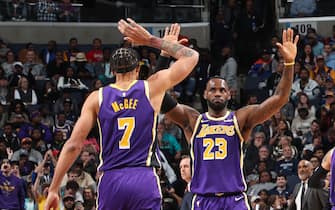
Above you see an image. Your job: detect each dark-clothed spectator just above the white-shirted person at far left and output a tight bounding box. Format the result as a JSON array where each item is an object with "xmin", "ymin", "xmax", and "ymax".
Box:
[{"xmin": 23, "ymin": 50, "xmax": 46, "ymax": 80}]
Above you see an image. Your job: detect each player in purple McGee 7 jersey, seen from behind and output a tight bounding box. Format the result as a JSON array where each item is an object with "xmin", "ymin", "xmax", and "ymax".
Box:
[{"xmin": 45, "ymin": 19, "xmax": 198, "ymax": 210}]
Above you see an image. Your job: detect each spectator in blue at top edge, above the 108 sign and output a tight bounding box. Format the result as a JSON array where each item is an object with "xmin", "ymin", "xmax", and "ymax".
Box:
[{"xmin": 290, "ymin": 0, "xmax": 316, "ymax": 17}]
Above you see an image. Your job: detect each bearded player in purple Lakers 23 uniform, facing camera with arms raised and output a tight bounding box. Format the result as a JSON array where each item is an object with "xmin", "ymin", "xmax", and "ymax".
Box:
[{"xmin": 163, "ymin": 29, "xmax": 299, "ymax": 210}]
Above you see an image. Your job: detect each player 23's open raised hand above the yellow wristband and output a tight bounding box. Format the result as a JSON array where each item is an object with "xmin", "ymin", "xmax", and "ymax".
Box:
[{"xmin": 276, "ymin": 28, "xmax": 299, "ymax": 63}]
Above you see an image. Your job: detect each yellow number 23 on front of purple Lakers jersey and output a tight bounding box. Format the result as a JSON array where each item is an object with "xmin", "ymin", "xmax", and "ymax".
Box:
[{"xmin": 202, "ymin": 138, "xmax": 227, "ymax": 160}]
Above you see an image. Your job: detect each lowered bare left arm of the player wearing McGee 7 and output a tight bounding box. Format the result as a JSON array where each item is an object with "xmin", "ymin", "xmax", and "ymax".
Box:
[{"xmin": 45, "ymin": 91, "xmax": 99, "ymax": 210}]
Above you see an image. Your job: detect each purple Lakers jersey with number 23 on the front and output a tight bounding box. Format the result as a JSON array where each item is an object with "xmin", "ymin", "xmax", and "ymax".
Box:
[{"xmin": 191, "ymin": 112, "xmax": 246, "ymax": 194}]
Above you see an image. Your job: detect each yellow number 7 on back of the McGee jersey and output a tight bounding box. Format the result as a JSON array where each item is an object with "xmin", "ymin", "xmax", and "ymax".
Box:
[{"xmin": 117, "ymin": 117, "xmax": 135, "ymax": 149}]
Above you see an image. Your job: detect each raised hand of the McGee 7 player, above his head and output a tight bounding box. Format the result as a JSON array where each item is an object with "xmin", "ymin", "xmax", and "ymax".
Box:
[{"xmin": 118, "ymin": 18, "xmax": 152, "ymax": 46}]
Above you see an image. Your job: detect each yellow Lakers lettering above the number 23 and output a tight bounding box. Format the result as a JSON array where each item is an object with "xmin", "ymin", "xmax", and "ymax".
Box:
[{"xmin": 196, "ymin": 124, "xmax": 235, "ymax": 138}]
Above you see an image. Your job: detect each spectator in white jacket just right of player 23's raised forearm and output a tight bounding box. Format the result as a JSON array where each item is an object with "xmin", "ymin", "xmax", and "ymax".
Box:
[{"xmin": 291, "ymin": 67, "xmax": 320, "ymax": 105}]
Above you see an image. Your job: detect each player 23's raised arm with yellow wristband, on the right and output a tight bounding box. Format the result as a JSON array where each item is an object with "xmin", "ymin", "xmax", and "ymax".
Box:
[{"xmin": 236, "ymin": 29, "xmax": 299, "ymax": 139}]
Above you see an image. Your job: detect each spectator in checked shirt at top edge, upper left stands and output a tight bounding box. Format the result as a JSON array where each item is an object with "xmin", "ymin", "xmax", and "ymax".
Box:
[{"xmin": 37, "ymin": 0, "xmax": 59, "ymax": 22}]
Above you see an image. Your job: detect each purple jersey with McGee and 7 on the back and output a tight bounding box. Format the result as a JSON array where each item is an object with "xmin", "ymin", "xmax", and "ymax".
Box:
[{"xmin": 98, "ymin": 80, "xmax": 157, "ymax": 171}]
